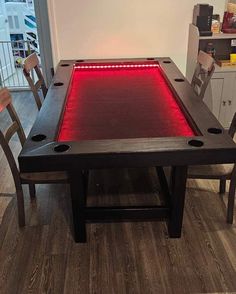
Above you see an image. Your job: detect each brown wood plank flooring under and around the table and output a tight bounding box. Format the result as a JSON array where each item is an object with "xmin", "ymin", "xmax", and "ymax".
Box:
[{"xmin": 0, "ymin": 92, "xmax": 236, "ymax": 294}]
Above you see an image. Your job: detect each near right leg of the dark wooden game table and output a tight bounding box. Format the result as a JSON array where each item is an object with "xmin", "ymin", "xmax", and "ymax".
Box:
[{"xmin": 168, "ymin": 166, "xmax": 187, "ymax": 238}]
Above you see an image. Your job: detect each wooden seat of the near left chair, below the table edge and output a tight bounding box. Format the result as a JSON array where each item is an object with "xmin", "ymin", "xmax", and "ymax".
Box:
[{"xmin": 20, "ymin": 171, "xmax": 69, "ymax": 184}]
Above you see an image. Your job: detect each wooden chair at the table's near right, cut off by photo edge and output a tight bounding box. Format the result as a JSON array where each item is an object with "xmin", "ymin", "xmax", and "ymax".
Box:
[{"xmin": 188, "ymin": 113, "xmax": 236, "ymax": 224}]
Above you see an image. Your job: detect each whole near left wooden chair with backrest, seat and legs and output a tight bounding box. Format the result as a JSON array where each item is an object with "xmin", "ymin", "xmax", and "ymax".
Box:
[{"xmin": 0, "ymin": 88, "xmax": 68, "ymax": 226}]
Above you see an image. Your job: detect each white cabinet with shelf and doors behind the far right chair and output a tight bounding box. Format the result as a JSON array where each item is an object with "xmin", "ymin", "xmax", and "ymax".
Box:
[{"xmin": 186, "ymin": 24, "xmax": 236, "ymax": 128}]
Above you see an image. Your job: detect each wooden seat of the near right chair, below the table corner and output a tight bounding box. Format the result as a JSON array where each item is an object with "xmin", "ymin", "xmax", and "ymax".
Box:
[{"xmin": 188, "ymin": 164, "xmax": 234, "ymax": 179}]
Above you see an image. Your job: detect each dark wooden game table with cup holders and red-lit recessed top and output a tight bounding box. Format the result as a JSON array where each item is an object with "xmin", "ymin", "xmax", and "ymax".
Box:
[{"xmin": 18, "ymin": 58, "xmax": 236, "ymax": 242}]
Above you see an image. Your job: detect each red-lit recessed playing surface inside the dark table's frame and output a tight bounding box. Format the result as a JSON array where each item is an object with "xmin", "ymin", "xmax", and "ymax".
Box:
[{"xmin": 58, "ymin": 63, "xmax": 195, "ymax": 141}]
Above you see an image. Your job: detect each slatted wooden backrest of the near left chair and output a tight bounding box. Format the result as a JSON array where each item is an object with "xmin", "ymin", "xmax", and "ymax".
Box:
[{"xmin": 0, "ymin": 88, "xmax": 26, "ymax": 189}]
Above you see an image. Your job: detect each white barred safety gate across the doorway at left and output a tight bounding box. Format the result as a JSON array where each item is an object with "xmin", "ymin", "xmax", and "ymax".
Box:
[{"xmin": 0, "ymin": 40, "xmax": 34, "ymax": 90}]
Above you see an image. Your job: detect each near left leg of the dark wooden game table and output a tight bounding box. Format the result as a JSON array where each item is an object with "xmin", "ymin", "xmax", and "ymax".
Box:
[{"xmin": 69, "ymin": 171, "xmax": 86, "ymax": 243}]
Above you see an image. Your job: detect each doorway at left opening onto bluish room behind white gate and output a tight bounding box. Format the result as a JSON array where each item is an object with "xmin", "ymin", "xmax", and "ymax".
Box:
[{"xmin": 0, "ymin": 0, "xmax": 53, "ymax": 90}]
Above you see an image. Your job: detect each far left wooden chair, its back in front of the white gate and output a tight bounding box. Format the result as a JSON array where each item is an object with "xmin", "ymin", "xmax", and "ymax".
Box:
[{"xmin": 23, "ymin": 53, "xmax": 47, "ymax": 109}]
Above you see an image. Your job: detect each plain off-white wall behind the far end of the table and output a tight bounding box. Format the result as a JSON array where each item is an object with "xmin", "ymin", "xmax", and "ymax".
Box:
[{"xmin": 48, "ymin": 0, "xmax": 225, "ymax": 73}]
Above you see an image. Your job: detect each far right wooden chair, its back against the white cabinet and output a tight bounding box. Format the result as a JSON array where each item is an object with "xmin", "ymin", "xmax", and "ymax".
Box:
[{"xmin": 191, "ymin": 50, "xmax": 215, "ymax": 99}]
